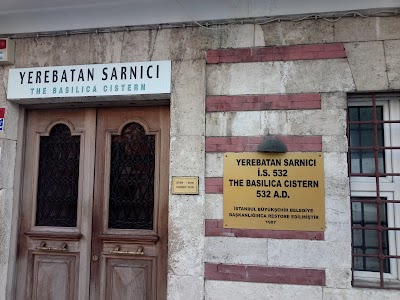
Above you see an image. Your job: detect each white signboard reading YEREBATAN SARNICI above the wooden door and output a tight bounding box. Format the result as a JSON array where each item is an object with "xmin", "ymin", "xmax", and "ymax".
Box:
[{"xmin": 7, "ymin": 61, "xmax": 171, "ymax": 100}]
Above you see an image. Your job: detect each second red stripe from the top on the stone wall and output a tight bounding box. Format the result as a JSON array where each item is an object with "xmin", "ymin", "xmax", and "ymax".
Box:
[{"xmin": 206, "ymin": 94, "xmax": 321, "ymax": 112}]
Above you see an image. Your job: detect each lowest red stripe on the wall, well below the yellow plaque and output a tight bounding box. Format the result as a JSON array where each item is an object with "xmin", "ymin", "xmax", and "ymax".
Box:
[{"xmin": 204, "ymin": 263, "xmax": 326, "ymax": 286}]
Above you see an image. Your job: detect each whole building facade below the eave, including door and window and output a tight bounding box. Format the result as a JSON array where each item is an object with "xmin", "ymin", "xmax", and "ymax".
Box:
[{"xmin": 0, "ymin": 8, "xmax": 400, "ymax": 300}]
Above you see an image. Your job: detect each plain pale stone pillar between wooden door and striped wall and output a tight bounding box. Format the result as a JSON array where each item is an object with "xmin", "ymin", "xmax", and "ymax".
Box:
[{"xmin": 168, "ymin": 60, "xmax": 205, "ymax": 300}]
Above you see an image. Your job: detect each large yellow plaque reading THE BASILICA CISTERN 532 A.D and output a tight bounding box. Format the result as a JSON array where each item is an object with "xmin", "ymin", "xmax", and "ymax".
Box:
[{"xmin": 224, "ymin": 152, "xmax": 325, "ymax": 231}]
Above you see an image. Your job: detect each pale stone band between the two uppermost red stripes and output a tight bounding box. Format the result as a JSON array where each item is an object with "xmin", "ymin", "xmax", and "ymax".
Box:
[{"xmin": 207, "ymin": 59, "xmax": 354, "ymax": 95}]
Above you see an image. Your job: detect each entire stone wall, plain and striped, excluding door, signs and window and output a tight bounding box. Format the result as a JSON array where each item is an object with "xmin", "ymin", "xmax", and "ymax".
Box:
[{"xmin": 0, "ymin": 17, "xmax": 400, "ymax": 300}]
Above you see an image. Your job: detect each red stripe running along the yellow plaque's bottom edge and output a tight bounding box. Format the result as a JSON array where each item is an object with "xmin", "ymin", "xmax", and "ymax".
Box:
[{"xmin": 205, "ymin": 219, "xmax": 325, "ymax": 241}]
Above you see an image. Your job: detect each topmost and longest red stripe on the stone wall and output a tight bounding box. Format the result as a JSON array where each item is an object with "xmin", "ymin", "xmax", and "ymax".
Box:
[{"xmin": 206, "ymin": 43, "xmax": 346, "ymax": 64}]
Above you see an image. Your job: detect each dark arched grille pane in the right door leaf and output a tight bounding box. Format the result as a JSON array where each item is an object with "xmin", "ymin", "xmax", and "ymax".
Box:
[{"xmin": 108, "ymin": 123, "xmax": 155, "ymax": 230}]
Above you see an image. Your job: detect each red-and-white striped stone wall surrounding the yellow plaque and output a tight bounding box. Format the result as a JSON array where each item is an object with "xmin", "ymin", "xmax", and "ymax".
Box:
[{"xmin": 205, "ymin": 18, "xmax": 400, "ymax": 300}]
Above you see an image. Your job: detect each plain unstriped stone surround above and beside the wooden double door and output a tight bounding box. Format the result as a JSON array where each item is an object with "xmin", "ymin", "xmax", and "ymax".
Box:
[{"xmin": 0, "ymin": 28, "xmax": 211, "ymax": 300}]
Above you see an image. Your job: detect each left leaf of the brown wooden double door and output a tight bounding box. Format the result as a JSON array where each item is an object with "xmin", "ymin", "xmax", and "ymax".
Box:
[{"xmin": 16, "ymin": 109, "xmax": 96, "ymax": 299}]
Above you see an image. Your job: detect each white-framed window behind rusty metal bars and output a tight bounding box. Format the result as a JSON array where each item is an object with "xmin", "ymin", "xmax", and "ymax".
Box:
[{"xmin": 347, "ymin": 93, "xmax": 400, "ymax": 289}]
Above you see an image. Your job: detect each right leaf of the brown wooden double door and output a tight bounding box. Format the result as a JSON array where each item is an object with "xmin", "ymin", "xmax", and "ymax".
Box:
[{"xmin": 91, "ymin": 107, "xmax": 169, "ymax": 300}]
